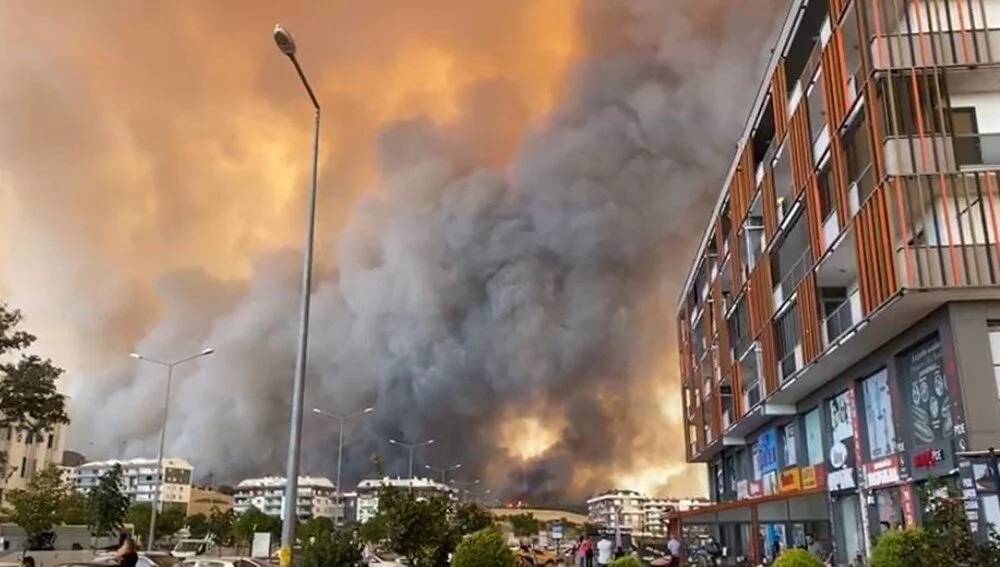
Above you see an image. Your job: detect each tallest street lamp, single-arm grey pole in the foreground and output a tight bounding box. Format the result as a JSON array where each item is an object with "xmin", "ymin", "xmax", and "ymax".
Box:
[{"xmin": 274, "ymin": 25, "xmax": 320, "ymax": 567}]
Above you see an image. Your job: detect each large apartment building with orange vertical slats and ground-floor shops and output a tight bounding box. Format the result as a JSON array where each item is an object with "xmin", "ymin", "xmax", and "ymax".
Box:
[{"xmin": 678, "ymin": 0, "xmax": 1000, "ymax": 562}]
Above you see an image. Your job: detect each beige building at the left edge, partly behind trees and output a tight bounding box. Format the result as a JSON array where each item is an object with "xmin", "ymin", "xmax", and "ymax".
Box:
[{"xmin": 0, "ymin": 425, "xmax": 66, "ymax": 502}]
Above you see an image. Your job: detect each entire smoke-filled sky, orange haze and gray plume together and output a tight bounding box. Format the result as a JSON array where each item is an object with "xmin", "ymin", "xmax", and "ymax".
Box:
[{"xmin": 0, "ymin": 0, "xmax": 783, "ymax": 499}]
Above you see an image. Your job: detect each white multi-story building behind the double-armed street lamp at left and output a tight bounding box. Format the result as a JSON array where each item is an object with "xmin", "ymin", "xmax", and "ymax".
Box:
[{"xmin": 68, "ymin": 458, "xmax": 194, "ymax": 510}]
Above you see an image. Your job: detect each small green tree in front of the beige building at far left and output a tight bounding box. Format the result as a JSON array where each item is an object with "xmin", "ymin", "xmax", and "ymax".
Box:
[{"xmin": 9, "ymin": 467, "xmax": 69, "ymax": 548}]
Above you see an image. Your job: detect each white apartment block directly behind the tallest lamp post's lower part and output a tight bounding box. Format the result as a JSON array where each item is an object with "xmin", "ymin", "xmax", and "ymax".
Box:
[{"xmin": 233, "ymin": 476, "xmax": 335, "ymax": 520}]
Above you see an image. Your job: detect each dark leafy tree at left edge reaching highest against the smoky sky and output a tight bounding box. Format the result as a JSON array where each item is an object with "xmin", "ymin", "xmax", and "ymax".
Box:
[{"xmin": 0, "ymin": 302, "xmax": 69, "ymax": 470}]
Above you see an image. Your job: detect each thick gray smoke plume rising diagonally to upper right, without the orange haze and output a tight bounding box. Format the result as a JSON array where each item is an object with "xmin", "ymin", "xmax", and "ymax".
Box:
[{"xmin": 7, "ymin": 0, "xmax": 785, "ymax": 500}]
